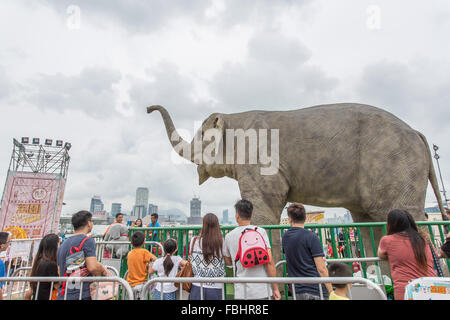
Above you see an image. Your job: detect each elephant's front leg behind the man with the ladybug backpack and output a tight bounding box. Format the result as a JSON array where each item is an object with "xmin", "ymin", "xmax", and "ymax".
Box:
[{"xmin": 238, "ymin": 170, "xmax": 289, "ymax": 275}]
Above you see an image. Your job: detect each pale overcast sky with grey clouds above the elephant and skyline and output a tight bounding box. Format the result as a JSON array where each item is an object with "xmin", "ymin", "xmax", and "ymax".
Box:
[{"xmin": 0, "ymin": 0, "xmax": 450, "ymax": 217}]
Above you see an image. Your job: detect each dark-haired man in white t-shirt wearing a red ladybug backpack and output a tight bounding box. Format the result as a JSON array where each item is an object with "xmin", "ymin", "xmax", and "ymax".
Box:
[{"xmin": 224, "ymin": 199, "xmax": 281, "ymax": 300}]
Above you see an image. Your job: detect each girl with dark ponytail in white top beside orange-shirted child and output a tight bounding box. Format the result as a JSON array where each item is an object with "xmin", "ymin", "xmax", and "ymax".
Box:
[{"xmin": 150, "ymin": 239, "xmax": 186, "ymax": 300}]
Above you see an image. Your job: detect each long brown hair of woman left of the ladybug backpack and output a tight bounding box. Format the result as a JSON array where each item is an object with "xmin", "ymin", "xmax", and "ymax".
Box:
[{"xmin": 200, "ymin": 213, "xmax": 223, "ymax": 263}]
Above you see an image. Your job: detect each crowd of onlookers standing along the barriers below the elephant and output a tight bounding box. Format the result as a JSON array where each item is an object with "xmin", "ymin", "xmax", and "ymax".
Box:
[{"xmin": 0, "ymin": 204, "xmax": 450, "ymax": 300}]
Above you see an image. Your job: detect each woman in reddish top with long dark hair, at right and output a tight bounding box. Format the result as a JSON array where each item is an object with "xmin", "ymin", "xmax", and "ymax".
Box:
[{"xmin": 378, "ymin": 209, "xmax": 436, "ymax": 300}]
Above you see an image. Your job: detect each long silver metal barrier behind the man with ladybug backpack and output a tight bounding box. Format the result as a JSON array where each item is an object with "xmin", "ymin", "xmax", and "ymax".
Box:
[{"xmin": 141, "ymin": 277, "xmax": 387, "ymax": 300}]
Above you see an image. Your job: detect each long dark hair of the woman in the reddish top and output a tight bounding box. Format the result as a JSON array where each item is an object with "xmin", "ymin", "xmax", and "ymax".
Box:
[{"xmin": 387, "ymin": 209, "xmax": 428, "ymax": 271}]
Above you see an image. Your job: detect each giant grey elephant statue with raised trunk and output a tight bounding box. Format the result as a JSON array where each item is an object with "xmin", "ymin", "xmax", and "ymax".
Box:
[{"xmin": 147, "ymin": 103, "xmax": 444, "ymax": 268}]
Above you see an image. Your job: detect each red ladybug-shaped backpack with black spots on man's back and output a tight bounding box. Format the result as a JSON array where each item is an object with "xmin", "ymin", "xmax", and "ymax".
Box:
[{"xmin": 234, "ymin": 227, "xmax": 269, "ymax": 268}]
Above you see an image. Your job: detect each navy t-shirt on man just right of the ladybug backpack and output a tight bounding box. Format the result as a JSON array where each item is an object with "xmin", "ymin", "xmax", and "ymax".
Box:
[{"xmin": 282, "ymin": 227, "xmax": 328, "ymax": 299}]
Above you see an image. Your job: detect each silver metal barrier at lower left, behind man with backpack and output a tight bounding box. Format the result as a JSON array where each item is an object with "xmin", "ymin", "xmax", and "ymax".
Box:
[{"xmin": 1, "ymin": 277, "xmax": 134, "ymax": 300}]
